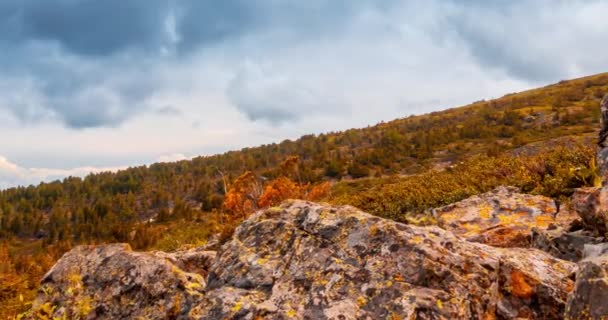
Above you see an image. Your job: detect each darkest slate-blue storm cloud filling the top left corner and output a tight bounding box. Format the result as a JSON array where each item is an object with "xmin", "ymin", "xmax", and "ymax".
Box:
[{"xmin": 0, "ymin": 0, "xmax": 168, "ymax": 56}]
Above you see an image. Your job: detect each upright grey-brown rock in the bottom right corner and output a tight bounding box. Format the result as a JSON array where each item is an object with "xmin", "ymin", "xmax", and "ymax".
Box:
[{"xmin": 565, "ymin": 255, "xmax": 608, "ymax": 320}]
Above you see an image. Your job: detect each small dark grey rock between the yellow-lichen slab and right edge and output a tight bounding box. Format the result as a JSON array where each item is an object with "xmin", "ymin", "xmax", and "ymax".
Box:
[{"xmin": 532, "ymin": 228, "xmax": 604, "ymax": 262}]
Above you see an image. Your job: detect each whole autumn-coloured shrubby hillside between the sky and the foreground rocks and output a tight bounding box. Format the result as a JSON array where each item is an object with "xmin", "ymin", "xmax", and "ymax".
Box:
[{"xmin": 0, "ymin": 74, "xmax": 608, "ymax": 318}]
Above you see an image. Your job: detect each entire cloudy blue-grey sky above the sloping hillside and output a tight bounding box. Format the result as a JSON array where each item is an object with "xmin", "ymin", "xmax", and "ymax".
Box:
[{"xmin": 0, "ymin": 0, "xmax": 608, "ymax": 188}]
